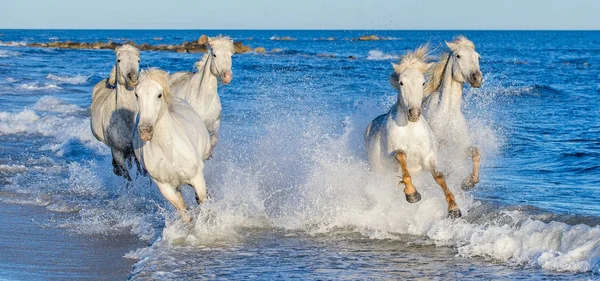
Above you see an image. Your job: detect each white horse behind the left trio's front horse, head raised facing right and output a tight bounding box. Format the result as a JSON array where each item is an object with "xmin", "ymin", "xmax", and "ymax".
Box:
[{"xmin": 169, "ymin": 36, "xmax": 235, "ymax": 158}]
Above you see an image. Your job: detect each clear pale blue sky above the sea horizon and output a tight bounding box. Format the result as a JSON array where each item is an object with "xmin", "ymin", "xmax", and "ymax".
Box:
[{"xmin": 0, "ymin": 0, "xmax": 600, "ymax": 30}]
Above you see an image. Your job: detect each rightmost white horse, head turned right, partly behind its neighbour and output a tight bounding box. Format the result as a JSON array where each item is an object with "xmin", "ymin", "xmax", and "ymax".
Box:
[{"xmin": 425, "ymin": 36, "xmax": 482, "ymax": 191}]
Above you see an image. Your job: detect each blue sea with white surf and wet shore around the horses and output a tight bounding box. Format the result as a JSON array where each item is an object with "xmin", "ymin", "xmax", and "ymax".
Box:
[{"xmin": 0, "ymin": 30, "xmax": 600, "ymax": 280}]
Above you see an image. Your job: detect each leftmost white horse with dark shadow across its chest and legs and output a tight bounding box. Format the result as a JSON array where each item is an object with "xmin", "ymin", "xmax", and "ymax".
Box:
[{"xmin": 90, "ymin": 45, "xmax": 140, "ymax": 180}]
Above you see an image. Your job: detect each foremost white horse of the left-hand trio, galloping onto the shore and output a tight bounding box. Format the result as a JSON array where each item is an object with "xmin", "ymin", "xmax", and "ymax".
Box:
[{"xmin": 133, "ymin": 69, "xmax": 210, "ymax": 222}]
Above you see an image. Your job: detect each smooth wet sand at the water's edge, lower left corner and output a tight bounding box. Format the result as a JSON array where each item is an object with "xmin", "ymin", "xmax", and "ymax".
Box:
[{"xmin": 0, "ymin": 203, "xmax": 146, "ymax": 280}]
